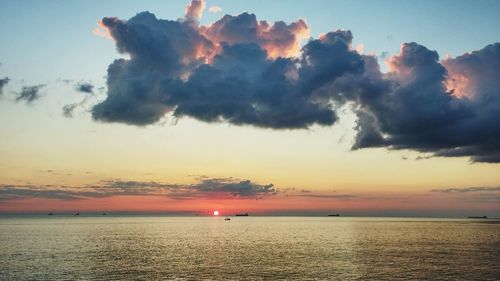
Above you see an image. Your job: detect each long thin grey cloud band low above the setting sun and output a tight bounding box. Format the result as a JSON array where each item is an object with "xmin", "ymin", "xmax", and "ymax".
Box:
[{"xmin": 0, "ymin": 178, "xmax": 278, "ymax": 200}]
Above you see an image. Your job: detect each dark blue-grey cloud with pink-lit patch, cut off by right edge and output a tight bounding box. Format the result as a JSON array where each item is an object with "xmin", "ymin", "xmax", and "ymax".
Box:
[{"xmin": 356, "ymin": 43, "xmax": 500, "ymax": 162}]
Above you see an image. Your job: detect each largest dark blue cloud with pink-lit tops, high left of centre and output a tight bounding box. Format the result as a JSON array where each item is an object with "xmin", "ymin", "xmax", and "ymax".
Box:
[{"xmin": 92, "ymin": 5, "xmax": 344, "ymax": 129}]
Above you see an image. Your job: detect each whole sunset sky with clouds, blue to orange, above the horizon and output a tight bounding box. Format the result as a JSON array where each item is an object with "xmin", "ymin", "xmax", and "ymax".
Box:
[{"xmin": 0, "ymin": 0, "xmax": 500, "ymax": 216}]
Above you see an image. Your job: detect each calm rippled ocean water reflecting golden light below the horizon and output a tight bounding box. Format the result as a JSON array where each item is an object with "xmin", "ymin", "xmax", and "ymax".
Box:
[{"xmin": 0, "ymin": 216, "xmax": 500, "ymax": 280}]
